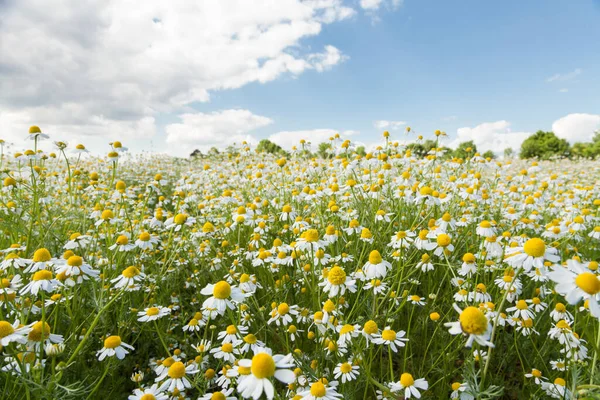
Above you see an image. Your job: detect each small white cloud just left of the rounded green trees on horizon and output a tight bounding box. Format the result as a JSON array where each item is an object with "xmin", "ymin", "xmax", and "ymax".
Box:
[{"xmin": 448, "ymin": 121, "xmax": 531, "ymax": 154}]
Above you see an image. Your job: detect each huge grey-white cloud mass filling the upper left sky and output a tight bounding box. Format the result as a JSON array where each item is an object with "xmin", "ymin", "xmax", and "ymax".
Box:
[{"xmin": 0, "ymin": 0, "xmax": 355, "ymax": 150}]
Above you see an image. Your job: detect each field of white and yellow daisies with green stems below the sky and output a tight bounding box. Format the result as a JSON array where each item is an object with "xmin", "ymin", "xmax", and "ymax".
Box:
[{"xmin": 0, "ymin": 127, "xmax": 600, "ymax": 400}]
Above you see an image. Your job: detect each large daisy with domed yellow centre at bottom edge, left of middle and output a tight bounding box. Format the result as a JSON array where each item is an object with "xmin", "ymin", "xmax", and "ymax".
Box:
[{"xmin": 237, "ymin": 348, "xmax": 296, "ymax": 400}]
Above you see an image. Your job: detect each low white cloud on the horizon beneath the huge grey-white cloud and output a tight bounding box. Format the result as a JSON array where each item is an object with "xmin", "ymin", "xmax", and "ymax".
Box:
[{"xmin": 165, "ymin": 110, "xmax": 273, "ymax": 155}]
